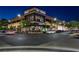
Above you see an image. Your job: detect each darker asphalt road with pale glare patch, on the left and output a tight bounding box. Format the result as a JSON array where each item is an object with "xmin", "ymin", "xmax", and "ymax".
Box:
[{"xmin": 0, "ymin": 34, "xmax": 52, "ymax": 46}]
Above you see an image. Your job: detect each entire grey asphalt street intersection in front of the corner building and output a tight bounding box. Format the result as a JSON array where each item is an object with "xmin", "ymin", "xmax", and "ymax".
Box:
[{"xmin": 0, "ymin": 33, "xmax": 79, "ymax": 49}]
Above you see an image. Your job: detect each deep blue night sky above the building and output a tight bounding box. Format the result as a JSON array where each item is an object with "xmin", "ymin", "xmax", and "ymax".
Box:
[{"xmin": 0, "ymin": 6, "xmax": 79, "ymax": 21}]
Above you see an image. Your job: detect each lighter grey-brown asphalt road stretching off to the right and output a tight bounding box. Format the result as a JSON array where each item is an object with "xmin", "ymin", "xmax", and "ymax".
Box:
[{"xmin": 41, "ymin": 33, "xmax": 79, "ymax": 49}]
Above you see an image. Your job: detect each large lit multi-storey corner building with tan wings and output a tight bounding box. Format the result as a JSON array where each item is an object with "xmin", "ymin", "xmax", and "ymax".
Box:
[{"xmin": 8, "ymin": 8, "xmax": 66, "ymax": 32}]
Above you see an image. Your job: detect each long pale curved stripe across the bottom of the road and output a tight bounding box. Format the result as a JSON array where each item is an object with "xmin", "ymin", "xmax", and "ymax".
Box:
[{"xmin": 0, "ymin": 46, "xmax": 79, "ymax": 51}]
